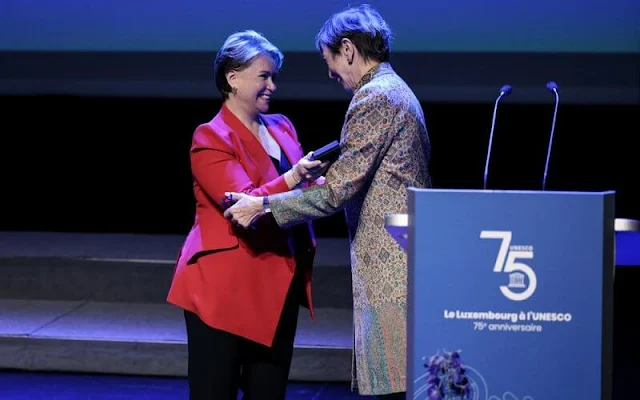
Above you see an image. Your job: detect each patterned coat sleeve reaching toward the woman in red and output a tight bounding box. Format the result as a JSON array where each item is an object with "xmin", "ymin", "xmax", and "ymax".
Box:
[{"xmin": 269, "ymin": 88, "xmax": 396, "ymax": 228}]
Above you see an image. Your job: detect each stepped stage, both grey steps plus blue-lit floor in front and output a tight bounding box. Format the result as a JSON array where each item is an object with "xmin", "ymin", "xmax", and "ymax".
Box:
[{"xmin": 0, "ymin": 232, "xmax": 640, "ymax": 400}]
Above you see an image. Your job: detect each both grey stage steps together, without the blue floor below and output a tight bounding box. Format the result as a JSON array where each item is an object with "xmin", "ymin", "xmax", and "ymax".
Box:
[{"xmin": 0, "ymin": 232, "xmax": 353, "ymax": 382}]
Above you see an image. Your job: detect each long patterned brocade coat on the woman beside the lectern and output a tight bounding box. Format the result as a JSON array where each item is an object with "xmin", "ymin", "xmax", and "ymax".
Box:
[{"xmin": 269, "ymin": 63, "xmax": 431, "ymax": 395}]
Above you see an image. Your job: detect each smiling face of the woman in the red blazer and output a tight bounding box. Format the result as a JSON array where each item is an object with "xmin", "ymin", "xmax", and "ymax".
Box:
[{"xmin": 227, "ymin": 55, "xmax": 278, "ymax": 113}]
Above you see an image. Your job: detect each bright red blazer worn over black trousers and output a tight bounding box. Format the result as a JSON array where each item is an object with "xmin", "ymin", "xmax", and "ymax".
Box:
[{"xmin": 167, "ymin": 105, "xmax": 316, "ymax": 346}]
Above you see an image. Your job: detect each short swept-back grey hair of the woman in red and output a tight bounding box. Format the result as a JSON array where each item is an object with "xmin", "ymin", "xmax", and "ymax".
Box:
[{"xmin": 213, "ymin": 30, "xmax": 284, "ymax": 99}]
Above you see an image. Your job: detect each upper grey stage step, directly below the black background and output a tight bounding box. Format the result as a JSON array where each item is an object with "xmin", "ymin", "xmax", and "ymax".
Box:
[{"xmin": 0, "ymin": 232, "xmax": 352, "ymax": 308}]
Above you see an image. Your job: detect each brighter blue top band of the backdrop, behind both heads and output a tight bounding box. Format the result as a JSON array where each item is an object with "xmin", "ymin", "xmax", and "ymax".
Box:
[{"xmin": 0, "ymin": 0, "xmax": 640, "ymax": 53}]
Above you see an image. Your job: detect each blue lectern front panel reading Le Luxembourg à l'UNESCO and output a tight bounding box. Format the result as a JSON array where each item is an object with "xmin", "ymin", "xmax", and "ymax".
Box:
[{"xmin": 408, "ymin": 190, "xmax": 614, "ymax": 400}]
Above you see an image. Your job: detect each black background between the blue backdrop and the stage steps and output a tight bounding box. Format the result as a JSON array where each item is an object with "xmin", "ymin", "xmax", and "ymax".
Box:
[{"xmin": 0, "ymin": 92, "xmax": 640, "ymax": 237}]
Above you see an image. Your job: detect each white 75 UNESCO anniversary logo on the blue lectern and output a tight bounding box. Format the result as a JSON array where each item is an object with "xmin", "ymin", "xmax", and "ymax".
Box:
[{"xmin": 480, "ymin": 231, "xmax": 538, "ymax": 301}]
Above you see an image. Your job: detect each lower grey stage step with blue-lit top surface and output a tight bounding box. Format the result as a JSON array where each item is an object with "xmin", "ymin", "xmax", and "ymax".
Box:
[{"xmin": 0, "ymin": 299, "xmax": 353, "ymax": 382}]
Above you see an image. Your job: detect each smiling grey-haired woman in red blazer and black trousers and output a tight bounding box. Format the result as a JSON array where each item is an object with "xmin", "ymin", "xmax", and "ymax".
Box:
[{"xmin": 167, "ymin": 31, "xmax": 322, "ymax": 400}]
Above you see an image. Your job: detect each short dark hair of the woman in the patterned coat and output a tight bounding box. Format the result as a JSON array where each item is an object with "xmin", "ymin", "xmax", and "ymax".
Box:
[{"xmin": 316, "ymin": 4, "xmax": 391, "ymax": 62}]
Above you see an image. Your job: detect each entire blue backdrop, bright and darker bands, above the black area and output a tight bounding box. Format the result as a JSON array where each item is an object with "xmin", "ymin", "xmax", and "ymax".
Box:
[{"xmin": 0, "ymin": 0, "xmax": 640, "ymax": 104}]
